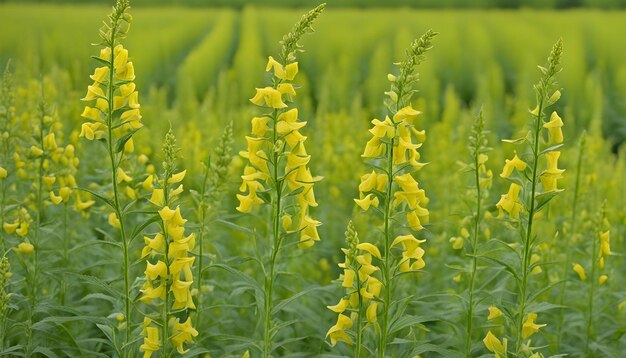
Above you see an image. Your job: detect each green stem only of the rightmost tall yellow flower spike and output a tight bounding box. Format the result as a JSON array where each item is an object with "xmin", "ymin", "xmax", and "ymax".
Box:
[{"xmin": 515, "ymin": 93, "xmax": 544, "ymax": 355}]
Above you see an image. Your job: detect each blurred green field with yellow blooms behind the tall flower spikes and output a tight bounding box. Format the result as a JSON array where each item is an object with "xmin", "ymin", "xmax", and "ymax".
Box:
[{"xmin": 0, "ymin": 2, "xmax": 626, "ymax": 358}]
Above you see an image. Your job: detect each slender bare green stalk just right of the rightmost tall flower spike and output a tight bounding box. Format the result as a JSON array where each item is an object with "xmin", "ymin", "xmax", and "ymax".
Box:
[{"xmin": 556, "ymin": 132, "xmax": 585, "ymax": 349}]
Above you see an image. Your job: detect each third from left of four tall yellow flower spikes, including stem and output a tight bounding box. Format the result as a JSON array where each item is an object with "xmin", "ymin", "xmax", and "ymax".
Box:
[{"xmin": 355, "ymin": 30, "xmax": 437, "ymax": 358}]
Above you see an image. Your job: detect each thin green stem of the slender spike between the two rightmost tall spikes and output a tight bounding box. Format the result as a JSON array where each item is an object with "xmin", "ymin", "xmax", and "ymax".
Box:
[{"xmin": 465, "ymin": 144, "xmax": 482, "ymax": 358}]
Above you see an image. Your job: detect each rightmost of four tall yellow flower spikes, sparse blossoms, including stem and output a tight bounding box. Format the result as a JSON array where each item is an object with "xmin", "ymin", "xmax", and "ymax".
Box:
[{"xmin": 488, "ymin": 40, "xmax": 564, "ymax": 356}]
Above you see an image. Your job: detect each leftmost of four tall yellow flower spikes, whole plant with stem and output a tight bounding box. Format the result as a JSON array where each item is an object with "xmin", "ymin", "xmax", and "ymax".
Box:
[{"xmin": 80, "ymin": 0, "xmax": 143, "ymax": 356}]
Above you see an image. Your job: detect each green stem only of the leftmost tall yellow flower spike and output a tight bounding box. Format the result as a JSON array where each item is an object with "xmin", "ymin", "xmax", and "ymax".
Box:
[{"xmin": 107, "ymin": 37, "xmax": 132, "ymax": 357}]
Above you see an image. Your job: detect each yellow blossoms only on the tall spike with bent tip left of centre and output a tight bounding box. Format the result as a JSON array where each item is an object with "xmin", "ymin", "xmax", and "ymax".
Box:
[{"xmin": 237, "ymin": 56, "xmax": 321, "ymax": 248}]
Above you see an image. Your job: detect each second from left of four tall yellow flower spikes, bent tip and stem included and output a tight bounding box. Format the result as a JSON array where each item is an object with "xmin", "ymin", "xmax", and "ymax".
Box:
[{"xmin": 237, "ymin": 4, "xmax": 325, "ymax": 357}]
